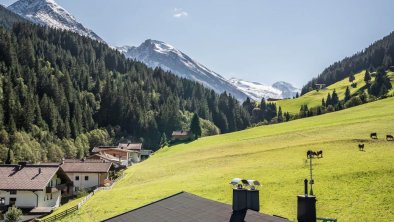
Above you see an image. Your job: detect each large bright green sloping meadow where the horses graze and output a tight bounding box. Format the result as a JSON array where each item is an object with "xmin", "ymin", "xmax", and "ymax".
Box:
[{"xmin": 63, "ymin": 97, "xmax": 394, "ymax": 221}]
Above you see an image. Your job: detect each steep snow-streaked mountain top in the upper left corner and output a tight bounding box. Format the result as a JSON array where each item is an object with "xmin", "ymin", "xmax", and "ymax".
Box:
[{"xmin": 8, "ymin": 0, "xmax": 104, "ymax": 42}]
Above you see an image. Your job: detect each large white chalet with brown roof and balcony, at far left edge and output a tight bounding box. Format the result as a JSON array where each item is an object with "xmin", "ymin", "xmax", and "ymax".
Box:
[{"xmin": 0, "ymin": 162, "xmax": 73, "ymax": 213}]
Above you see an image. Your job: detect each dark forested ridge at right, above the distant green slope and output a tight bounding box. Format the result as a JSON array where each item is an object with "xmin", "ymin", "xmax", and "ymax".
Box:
[{"xmin": 301, "ymin": 32, "xmax": 394, "ymax": 95}]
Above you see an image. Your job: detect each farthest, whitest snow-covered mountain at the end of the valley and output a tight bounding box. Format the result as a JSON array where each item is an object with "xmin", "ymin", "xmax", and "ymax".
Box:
[{"xmin": 230, "ymin": 78, "xmax": 299, "ymax": 101}]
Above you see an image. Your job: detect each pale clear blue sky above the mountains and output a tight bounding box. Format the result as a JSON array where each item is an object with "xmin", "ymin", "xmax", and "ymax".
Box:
[{"xmin": 0, "ymin": 0, "xmax": 394, "ymax": 87}]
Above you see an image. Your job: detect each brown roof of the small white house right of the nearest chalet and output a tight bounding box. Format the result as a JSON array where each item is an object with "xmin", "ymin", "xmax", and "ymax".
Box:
[{"xmin": 60, "ymin": 160, "xmax": 112, "ymax": 173}]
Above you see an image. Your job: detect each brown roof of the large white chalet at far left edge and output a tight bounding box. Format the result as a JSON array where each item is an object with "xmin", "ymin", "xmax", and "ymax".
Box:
[{"xmin": 0, "ymin": 165, "xmax": 59, "ymax": 190}]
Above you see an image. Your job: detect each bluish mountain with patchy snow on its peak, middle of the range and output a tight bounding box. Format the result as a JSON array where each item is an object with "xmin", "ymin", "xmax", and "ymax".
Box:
[{"xmin": 118, "ymin": 39, "xmax": 247, "ymax": 101}]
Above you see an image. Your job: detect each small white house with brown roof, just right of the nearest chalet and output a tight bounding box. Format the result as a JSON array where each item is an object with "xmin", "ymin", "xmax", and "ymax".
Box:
[{"xmin": 60, "ymin": 159, "xmax": 112, "ymax": 191}]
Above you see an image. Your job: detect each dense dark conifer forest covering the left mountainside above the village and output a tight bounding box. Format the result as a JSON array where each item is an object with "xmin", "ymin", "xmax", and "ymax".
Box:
[{"xmin": 0, "ymin": 12, "xmax": 250, "ymax": 162}]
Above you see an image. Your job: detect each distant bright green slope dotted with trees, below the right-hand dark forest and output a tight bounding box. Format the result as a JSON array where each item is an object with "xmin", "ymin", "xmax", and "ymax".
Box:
[{"xmin": 277, "ymin": 71, "xmax": 394, "ymax": 114}]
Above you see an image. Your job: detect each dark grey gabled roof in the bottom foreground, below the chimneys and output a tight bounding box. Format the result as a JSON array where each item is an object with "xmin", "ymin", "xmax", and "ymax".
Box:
[{"xmin": 104, "ymin": 192, "xmax": 288, "ymax": 222}]
